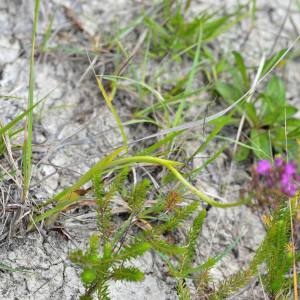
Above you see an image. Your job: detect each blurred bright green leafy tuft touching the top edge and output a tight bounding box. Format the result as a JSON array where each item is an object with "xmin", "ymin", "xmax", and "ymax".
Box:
[{"xmin": 145, "ymin": 0, "xmax": 244, "ymax": 58}]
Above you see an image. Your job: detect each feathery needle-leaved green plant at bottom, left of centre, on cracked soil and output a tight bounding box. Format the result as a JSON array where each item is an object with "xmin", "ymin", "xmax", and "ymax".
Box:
[{"xmin": 70, "ymin": 165, "xmax": 184, "ymax": 299}]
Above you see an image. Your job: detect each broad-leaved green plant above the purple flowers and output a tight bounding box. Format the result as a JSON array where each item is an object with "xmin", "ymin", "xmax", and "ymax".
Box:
[{"xmin": 215, "ymin": 50, "xmax": 300, "ymax": 160}]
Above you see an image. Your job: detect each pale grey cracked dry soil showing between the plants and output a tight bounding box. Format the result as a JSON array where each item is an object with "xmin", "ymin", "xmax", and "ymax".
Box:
[{"xmin": 0, "ymin": 0, "xmax": 300, "ymax": 300}]
